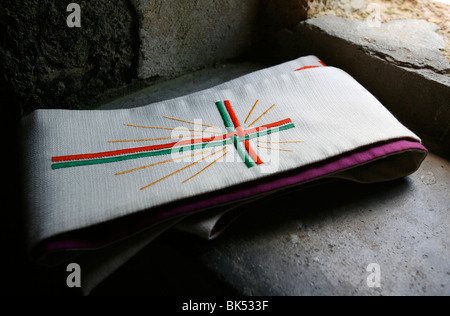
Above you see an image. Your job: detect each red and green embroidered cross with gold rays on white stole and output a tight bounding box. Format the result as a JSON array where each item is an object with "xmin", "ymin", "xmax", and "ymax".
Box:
[{"xmin": 52, "ymin": 61, "xmax": 326, "ymax": 190}]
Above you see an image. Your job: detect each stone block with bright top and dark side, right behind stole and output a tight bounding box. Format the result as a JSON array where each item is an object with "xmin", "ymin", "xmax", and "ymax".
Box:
[{"xmin": 270, "ymin": 17, "xmax": 450, "ymax": 158}]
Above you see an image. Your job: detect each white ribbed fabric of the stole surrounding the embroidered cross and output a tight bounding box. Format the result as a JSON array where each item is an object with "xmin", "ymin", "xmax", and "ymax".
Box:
[{"xmin": 23, "ymin": 56, "xmax": 423, "ymax": 289}]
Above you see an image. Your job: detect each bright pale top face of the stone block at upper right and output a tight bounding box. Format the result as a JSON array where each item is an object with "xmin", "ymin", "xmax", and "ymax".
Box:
[{"xmin": 308, "ymin": 16, "xmax": 450, "ymax": 74}]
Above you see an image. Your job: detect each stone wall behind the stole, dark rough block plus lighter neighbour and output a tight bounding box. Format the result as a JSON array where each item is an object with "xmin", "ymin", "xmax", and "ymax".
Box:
[{"xmin": 0, "ymin": 0, "xmax": 260, "ymax": 116}]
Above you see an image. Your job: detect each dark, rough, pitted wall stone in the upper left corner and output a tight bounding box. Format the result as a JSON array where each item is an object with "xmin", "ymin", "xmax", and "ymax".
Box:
[{"xmin": 0, "ymin": 0, "xmax": 137, "ymax": 115}]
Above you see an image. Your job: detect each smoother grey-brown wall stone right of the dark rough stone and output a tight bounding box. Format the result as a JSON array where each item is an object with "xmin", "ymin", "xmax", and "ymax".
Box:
[{"xmin": 134, "ymin": 0, "xmax": 259, "ymax": 79}]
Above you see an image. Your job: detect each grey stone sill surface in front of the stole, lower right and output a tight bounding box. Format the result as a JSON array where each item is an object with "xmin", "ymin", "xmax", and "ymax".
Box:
[{"xmin": 198, "ymin": 155, "xmax": 450, "ymax": 295}]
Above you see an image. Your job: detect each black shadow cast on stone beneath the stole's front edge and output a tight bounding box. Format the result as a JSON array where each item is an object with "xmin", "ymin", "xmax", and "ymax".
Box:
[{"xmin": 87, "ymin": 179, "xmax": 409, "ymax": 296}]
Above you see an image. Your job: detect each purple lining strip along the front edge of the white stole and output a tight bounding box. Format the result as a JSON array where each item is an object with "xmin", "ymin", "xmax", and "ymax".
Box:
[{"xmin": 33, "ymin": 140, "xmax": 427, "ymax": 255}]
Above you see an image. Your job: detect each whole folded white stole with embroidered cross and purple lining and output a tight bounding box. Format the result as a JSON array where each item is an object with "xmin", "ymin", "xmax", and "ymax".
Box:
[{"xmin": 22, "ymin": 56, "xmax": 427, "ymax": 292}]
